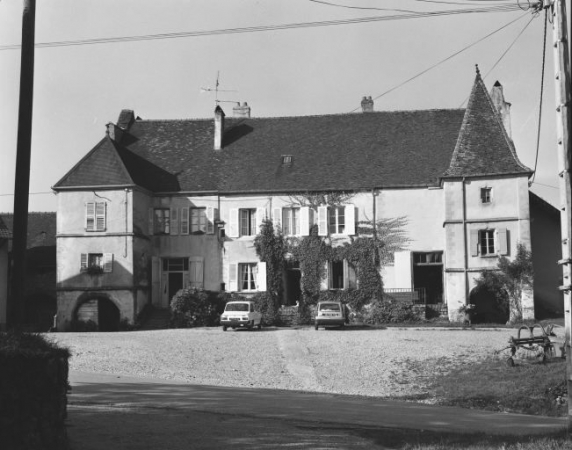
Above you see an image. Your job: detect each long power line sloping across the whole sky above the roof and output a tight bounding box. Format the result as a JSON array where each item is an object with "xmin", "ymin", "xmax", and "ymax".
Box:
[{"xmin": 0, "ymin": 5, "xmax": 520, "ymax": 51}]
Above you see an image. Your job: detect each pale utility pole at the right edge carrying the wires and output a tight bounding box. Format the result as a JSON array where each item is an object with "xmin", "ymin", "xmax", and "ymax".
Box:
[{"xmin": 545, "ymin": 0, "xmax": 572, "ymax": 432}]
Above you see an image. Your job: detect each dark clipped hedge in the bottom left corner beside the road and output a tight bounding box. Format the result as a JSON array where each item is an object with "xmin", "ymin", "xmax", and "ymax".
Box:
[{"xmin": 0, "ymin": 333, "xmax": 70, "ymax": 450}]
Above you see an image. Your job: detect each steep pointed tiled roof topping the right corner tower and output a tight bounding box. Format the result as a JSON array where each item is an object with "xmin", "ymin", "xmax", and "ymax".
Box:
[{"xmin": 445, "ymin": 72, "xmax": 532, "ymax": 177}]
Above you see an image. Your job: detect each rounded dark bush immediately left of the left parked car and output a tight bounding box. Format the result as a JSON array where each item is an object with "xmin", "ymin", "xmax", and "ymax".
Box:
[{"xmin": 170, "ymin": 288, "xmax": 228, "ymax": 328}]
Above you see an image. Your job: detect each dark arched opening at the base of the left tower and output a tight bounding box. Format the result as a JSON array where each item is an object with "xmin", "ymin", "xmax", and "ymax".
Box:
[{"xmin": 72, "ymin": 292, "xmax": 121, "ymax": 331}]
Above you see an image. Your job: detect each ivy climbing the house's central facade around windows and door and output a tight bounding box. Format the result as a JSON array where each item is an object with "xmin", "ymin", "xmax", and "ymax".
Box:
[{"xmin": 254, "ymin": 193, "xmax": 409, "ymax": 321}]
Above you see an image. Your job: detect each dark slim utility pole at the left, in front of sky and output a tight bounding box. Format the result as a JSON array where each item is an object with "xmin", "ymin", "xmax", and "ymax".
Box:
[{"xmin": 8, "ymin": 0, "xmax": 36, "ymax": 328}]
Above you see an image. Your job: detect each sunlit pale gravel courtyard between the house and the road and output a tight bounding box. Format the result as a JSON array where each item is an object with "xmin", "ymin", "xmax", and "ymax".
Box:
[{"xmin": 48, "ymin": 327, "xmax": 540, "ymax": 397}]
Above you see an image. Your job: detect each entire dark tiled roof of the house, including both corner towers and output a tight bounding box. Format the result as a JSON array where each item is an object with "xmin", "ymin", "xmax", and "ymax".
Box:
[{"xmin": 54, "ymin": 76, "xmax": 529, "ymax": 193}]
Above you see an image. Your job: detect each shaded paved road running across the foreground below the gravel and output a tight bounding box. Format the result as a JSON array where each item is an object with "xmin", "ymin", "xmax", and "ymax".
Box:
[{"xmin": 68, "ymin": 371, "xmax": 565, "ymax": 450}]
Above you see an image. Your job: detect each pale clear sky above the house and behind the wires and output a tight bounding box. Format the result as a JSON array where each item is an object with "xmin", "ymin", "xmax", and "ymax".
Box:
[{"xmin": 0, "ymin": 0, "xmax": 570, "ymax": 212}]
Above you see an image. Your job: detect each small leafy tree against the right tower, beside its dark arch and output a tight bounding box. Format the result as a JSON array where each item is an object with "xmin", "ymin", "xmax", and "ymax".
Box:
[{"xmin": 477, "ymin": 244, "xmax": 534, "ymax": 323}]
